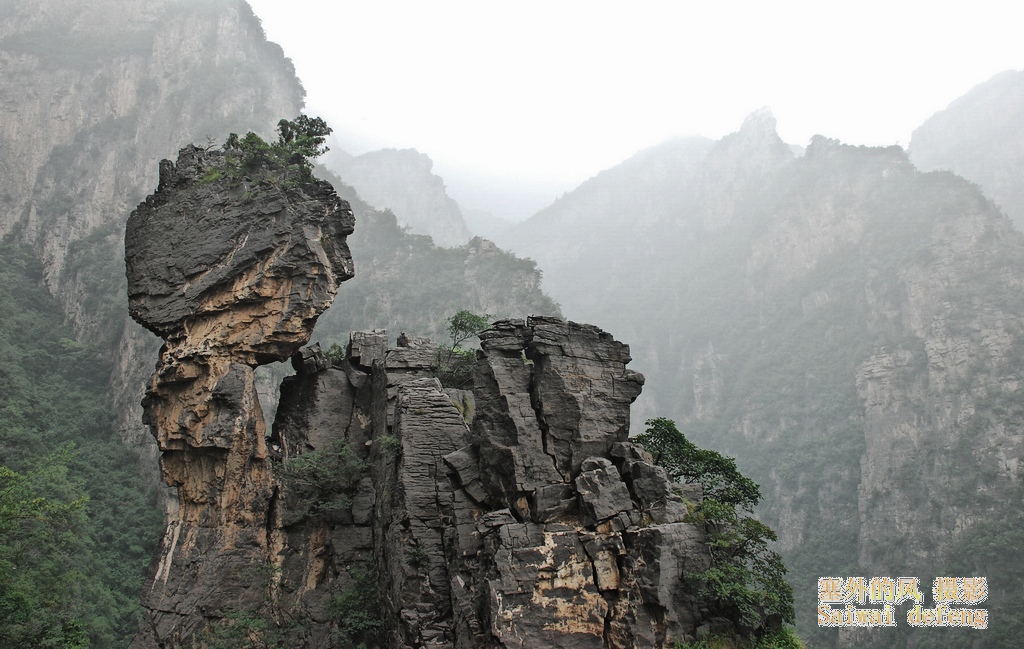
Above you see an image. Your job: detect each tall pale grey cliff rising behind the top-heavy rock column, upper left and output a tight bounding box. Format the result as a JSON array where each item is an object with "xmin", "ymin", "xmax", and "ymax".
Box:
[{"xmin": 0, "ymin": 0, "xmax": 304, "ymax": 481}]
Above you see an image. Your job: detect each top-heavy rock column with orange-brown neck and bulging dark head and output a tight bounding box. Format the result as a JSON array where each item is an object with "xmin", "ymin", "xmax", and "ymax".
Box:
[{"xmin": 125, "ymin": 146, "xmax": 354, "ymax": 647}]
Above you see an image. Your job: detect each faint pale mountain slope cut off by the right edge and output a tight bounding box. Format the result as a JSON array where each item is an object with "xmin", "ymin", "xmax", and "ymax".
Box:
[{"xmin": 909, "ymin": 70, "xmax": 1024, "ymax": 227}]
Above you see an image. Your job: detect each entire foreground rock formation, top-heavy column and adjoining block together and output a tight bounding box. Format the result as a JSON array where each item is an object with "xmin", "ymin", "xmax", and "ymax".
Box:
[{"xmin": 125, "ymin": 146, "xmax": 714, "ymax": 649}]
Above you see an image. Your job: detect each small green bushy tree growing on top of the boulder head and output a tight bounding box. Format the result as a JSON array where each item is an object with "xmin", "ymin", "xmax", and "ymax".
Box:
[{"xmin": 223, "ymin": 115, "xmax": 332, "ymax": 182}]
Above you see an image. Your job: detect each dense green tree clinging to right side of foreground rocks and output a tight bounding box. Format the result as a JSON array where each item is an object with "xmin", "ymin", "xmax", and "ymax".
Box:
[{"xmin": 636, "ymin": 418, "xmax": 796, "ymax": 638}]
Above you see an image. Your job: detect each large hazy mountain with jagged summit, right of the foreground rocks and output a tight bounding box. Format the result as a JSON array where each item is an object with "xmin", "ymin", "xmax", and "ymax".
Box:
[{"xmin": 501, "ymin": 112, "xmax": 1024, "ymax": 647}]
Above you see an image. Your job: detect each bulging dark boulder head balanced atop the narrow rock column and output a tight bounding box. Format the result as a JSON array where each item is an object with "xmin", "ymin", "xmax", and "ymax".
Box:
[{"xmin": 125, "ymin": 146, "xmax": 355, "ymax": 364}]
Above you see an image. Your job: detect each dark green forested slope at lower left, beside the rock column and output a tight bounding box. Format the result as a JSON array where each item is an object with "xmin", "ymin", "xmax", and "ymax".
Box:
[{"xmin": 0, "ymin": 240, "xmax": 163, "ymax": 647}]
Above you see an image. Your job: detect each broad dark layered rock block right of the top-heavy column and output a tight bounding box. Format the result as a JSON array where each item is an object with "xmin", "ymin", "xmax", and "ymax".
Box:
[{"xmin": 260, "ymin": 317, "xmax": 710, "ymax": 649}]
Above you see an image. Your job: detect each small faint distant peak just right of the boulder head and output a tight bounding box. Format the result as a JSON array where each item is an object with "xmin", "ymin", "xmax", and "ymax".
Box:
[{"xmin": 331, "ymin": 148, "xmax": 471, "ymax": 246}]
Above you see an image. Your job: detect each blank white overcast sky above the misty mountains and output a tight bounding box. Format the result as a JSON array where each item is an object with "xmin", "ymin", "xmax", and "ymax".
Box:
[{"xmin": 250, "ymin": 0, "xmax": 1024, "ymax": 195}]
